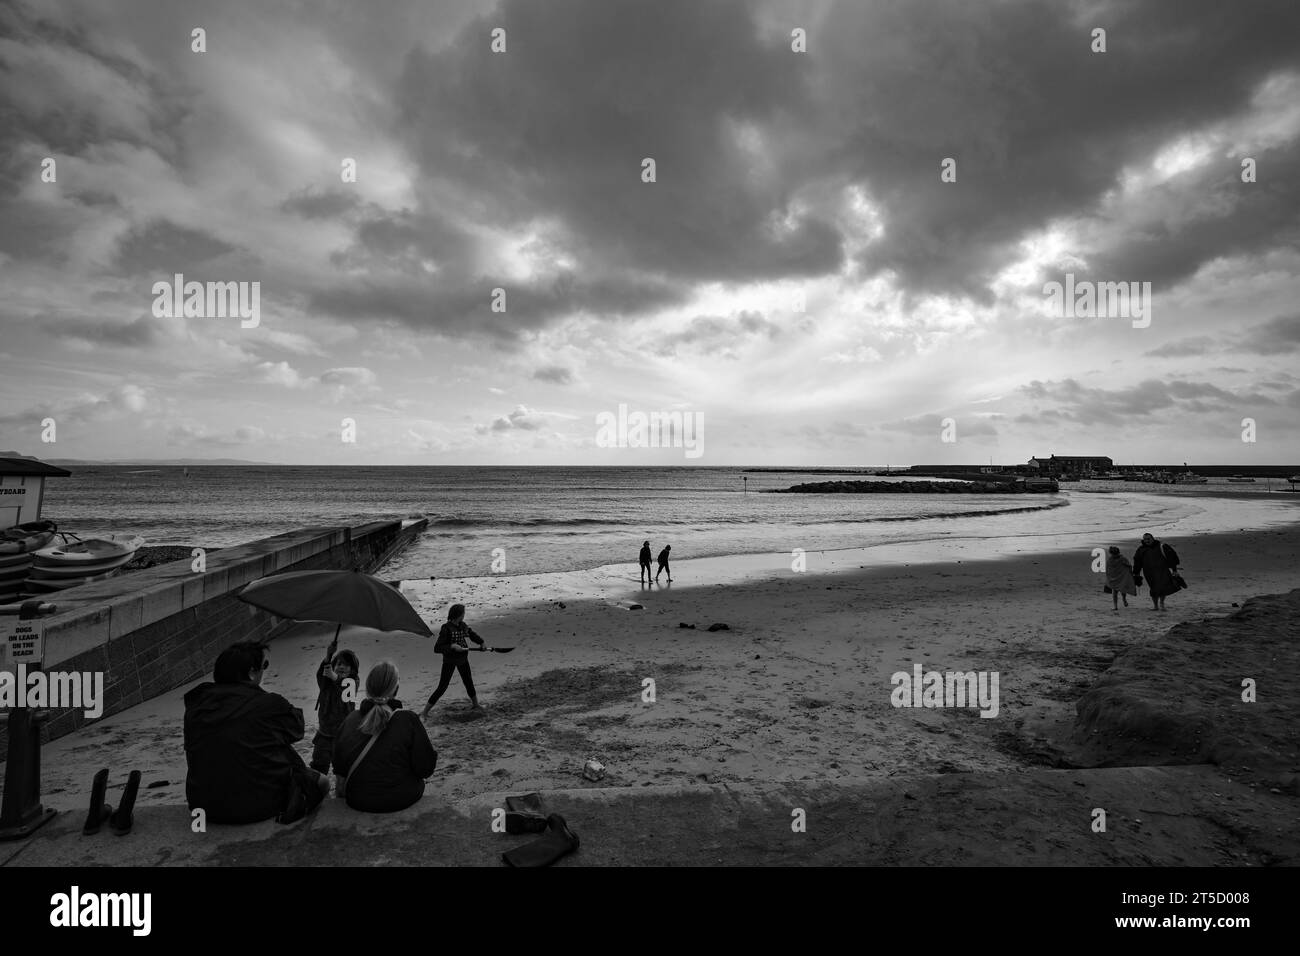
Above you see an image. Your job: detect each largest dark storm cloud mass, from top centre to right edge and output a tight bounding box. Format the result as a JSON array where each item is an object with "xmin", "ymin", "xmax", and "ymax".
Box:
[{"xmin": 379, "ymin": 0, "xmax": 1300, "ymax": 319}]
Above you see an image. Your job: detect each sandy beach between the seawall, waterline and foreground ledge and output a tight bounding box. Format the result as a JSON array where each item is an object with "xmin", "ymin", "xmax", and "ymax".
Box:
[{"xmin": 12, "ymin": 494, "xmax": 1300, "ymax": 862}]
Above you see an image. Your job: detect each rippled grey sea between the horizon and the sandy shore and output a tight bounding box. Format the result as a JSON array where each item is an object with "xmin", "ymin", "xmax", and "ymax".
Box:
[{"xmin": 42, "ymin": 466, "xmax": 1294, "ymax": 579}]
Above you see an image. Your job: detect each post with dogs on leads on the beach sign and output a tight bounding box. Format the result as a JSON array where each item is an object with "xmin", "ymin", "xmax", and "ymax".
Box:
[{"xmin": 0, "ymin": 601, "xmax": 59, "ymax": 842}]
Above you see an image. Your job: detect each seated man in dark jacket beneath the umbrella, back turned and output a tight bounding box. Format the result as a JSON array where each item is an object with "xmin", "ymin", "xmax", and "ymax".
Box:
[{"xmin": 185, "ymin": 641, "xmax": 329, "ymax": 823}]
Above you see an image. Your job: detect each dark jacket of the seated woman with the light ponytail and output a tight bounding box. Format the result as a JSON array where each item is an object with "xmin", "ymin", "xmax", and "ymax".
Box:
[{"xmin": 334, "ymin": 700, "xmax": 438, "ymax": 813}]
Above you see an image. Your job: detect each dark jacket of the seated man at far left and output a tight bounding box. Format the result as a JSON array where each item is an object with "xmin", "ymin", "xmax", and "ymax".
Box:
[{"xmin": 185, "ymin": 683, "xmax": 304, "ymax": 823}]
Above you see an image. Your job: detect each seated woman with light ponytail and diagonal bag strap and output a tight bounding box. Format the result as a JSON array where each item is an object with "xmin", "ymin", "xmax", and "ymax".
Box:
[{"xmin": 334, "ymin": 661, "xmax": 438, "ymax": 813}]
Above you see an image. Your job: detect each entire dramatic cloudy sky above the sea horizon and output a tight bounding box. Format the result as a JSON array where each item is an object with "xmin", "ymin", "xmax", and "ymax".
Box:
[{"xmin": 0, "ymin": 0, "xmax": 1300, "ymax": 464}]
